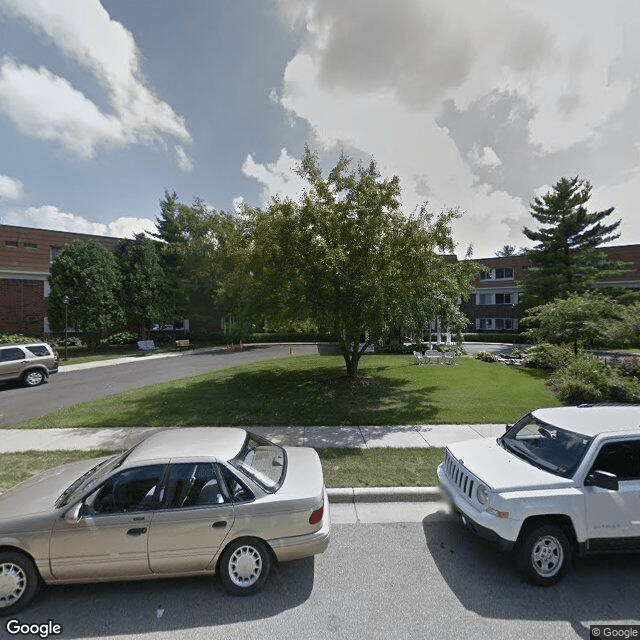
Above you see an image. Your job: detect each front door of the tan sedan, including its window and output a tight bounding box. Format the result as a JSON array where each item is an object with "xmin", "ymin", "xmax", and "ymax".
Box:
[{"xmin": 50, "ymin": 464, "xmax": 164, "ymax": 580}]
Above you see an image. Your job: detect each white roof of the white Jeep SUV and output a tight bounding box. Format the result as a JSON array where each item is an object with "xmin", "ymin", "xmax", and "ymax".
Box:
[{"xmin": 531, "ymin": 404, "xmax": 640, "ymax": 436}]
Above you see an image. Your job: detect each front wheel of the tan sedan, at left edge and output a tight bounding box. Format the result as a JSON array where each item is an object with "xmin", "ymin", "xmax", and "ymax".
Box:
[{"xmin": 0, "ymin": 551, "xmax": 40, "ymax": 617}]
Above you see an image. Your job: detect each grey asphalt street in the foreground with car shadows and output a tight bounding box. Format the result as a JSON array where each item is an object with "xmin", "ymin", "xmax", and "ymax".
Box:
[{"xmin": 10, "ymin": 505, "xmax": 640, "ymax": 640}]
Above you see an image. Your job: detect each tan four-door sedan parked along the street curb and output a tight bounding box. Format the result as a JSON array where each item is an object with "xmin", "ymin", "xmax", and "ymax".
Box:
[{"xmin": 0, "ymin": 427, "xmax": 330, "ymax": 616}]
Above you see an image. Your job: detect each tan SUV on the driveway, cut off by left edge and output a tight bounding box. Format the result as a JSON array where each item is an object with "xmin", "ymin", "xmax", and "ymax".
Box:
[{"xmin": 0, "ymin": 342, "xmax": 60, "ymax": 387}]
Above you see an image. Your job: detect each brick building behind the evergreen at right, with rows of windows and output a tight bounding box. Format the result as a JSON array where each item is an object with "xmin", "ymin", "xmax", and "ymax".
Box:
[{"xmin": 461, "ymin": 244, "xmax": 640, "ymax": 332}]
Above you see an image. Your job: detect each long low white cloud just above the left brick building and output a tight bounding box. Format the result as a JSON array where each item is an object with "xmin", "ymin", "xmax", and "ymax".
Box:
[{"xmin": 2, "ymin": 205, "xmax": 156, "ymax": 238}]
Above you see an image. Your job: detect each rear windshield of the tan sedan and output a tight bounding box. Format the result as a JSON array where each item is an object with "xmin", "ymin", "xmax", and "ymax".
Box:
[{"xmin": 229, "ymin": 433, "xmax": 287, "ymax": 493}]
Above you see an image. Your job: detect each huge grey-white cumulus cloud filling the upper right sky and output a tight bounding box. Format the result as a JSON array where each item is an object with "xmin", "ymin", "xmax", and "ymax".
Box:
[{"xmin": 264, "ymin": 0, "xmax": 637, "ymax": 255}]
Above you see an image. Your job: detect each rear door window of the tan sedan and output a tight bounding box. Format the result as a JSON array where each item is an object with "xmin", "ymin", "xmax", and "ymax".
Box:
[{"xmin": 160, "ymin": 462, "xmax": 225, "ymax": 509}]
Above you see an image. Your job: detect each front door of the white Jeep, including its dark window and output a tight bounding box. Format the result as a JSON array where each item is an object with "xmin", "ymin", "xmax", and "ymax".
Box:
[{"xmin": 584, "ymin": 439, "xmax": 640, "ymax": 551}]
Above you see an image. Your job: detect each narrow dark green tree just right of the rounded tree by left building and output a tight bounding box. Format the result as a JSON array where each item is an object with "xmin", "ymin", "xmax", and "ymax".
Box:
[{"xmin": 115, "ymin": 234, "xmax": 167, "ymax": 337}]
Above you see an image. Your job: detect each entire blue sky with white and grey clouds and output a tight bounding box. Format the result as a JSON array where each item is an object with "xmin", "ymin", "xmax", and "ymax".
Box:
[{"xmin": 0, "ymin": 0, "xmax": 640, "ymax": 258}]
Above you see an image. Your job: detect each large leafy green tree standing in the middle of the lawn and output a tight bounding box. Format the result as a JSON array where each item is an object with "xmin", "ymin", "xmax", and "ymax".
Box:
[{"xmin": 240, "ymin": 149, "xmax": 477, "ymax": 378}]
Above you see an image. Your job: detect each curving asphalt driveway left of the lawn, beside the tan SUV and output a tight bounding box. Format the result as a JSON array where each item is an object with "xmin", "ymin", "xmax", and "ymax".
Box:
[{"xmin": 0, "ymin": 345, "xmax": 318, "ymax": 427}]
